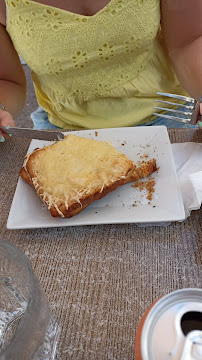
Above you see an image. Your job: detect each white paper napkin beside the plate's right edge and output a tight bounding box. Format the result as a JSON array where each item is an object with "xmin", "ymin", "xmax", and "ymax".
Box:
[{"xmin": 171, "ymin": 142, "xmax": 202, "ymax": 218}]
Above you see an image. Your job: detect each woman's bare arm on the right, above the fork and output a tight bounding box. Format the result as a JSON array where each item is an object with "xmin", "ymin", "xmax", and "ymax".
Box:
[{"xmin": 161, "ymin": 0, "xmax": 202, "ymax": 100}]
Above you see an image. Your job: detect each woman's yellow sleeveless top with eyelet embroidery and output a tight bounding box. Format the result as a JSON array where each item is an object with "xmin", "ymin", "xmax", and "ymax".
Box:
[{"xmin": 6, "ymin": 0, "xmax": 185, "ymax": 129}]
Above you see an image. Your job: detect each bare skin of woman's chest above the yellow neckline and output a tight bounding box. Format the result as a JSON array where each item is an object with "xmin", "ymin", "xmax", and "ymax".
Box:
[{"xmin": 32, "ymin": 0, "xmax": 113, "ymax": 16}]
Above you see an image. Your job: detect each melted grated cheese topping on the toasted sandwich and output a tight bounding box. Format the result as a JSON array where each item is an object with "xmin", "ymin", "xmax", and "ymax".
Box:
[{"xmin": 25, "ymin": 134, "xmax": 134, "ymax": 216}]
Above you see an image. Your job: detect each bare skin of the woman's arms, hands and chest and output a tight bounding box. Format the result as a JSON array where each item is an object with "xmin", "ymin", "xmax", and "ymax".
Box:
[{"xmin": 0, "ymin": 0, "xmax": 202, "ymax": 138}]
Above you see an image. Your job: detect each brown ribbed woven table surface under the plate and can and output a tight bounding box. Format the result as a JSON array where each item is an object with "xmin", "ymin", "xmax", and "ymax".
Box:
[{"xmin": 0, "ymin": 129, "xmax": 202, "ymax": 360}]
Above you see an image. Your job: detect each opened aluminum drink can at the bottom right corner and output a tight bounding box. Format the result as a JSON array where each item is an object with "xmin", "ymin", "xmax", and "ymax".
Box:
[{"xmin": 135, "ymin": 288, "xmax": 202, "ymax": 360}]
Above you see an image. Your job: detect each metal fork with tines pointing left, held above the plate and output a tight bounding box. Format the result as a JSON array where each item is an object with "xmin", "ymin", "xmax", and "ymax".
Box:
[{"xmin": 153, "ymin": 92, "xmax": 202, "ymax": 124}]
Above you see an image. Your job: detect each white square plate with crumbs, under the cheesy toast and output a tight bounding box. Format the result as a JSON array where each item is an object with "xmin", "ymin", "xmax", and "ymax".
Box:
[{"xmin": 7, "ymin": 126, "xmax": 185, "ymax": 229}]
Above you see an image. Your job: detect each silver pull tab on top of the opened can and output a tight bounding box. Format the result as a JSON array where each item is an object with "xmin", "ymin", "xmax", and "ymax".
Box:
[{"xmin": 180, "ymin": 330, "xmax": 202, "ymax": 360}]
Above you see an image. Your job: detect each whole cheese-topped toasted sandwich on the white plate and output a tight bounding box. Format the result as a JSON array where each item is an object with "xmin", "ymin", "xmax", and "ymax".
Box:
[{"xmin": 20, "ymin": 134, "xmax": 156, "ymax": 218}]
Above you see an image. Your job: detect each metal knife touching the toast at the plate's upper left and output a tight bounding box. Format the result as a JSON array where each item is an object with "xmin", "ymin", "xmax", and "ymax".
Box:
[{"xmin": 0, "ymin": 126, "xmax": 64, "ymax": 141}]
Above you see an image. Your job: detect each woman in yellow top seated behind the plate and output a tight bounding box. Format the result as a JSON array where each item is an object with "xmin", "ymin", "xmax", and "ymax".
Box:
[{"xmin": 0, "ymin": 0, "xmax": 202, "ymax": 142}]
